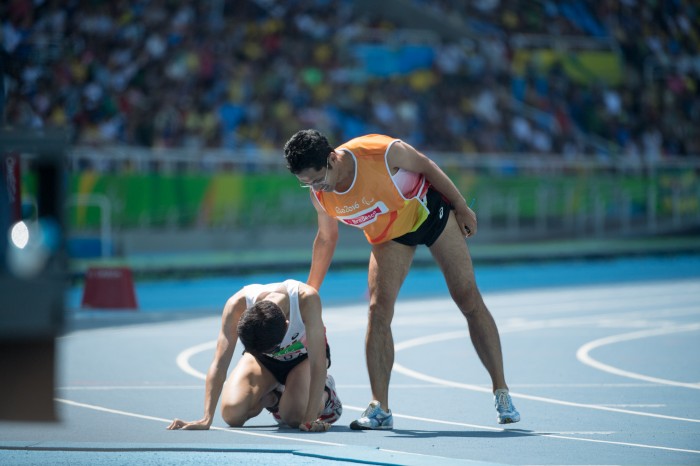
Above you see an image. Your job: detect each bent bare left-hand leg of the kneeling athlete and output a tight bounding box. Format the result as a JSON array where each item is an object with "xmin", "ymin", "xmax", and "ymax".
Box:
[{"xmin": 221, "ymin": 353, "xmax": 279, "ymax": 427}]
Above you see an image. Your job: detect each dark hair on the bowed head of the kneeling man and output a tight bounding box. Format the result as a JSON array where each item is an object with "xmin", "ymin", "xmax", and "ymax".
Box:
[{"xmin": 237, "ymin": 301, "xmax": 287, "ymax": 354}]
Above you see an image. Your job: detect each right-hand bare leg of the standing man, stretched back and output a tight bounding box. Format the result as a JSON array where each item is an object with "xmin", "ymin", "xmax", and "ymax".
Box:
[{"xmin": 430, "ymin": 212, "xmax": 508, "ymax": 391}]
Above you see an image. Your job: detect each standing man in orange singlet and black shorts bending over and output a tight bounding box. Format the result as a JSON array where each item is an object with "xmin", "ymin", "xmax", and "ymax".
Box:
[{"xmin": 284, "ymin": 129, "xmax": 520, "ymax": 429}]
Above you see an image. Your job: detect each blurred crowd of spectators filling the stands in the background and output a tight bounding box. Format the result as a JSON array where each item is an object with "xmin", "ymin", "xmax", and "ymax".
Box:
[{"xmin": 0, "ymin": 0, "xmax": 700, "ymax": 158}]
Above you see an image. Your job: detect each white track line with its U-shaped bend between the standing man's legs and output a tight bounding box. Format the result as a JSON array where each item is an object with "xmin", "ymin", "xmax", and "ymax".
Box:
[{"xmin": 393, "ymin": 331, "xmax": 700, "ymax": 423}]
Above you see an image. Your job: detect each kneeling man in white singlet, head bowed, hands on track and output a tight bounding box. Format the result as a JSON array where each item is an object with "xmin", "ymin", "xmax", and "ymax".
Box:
[{"xmin": 168, "ymin": 280, "xmax": 343, "ymax": 432}]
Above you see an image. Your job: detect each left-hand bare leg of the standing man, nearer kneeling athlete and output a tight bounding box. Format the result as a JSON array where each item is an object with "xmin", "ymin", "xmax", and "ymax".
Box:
[{"xmin": 365, "ymin": 241, "xmax": 416, "ymax": 411}]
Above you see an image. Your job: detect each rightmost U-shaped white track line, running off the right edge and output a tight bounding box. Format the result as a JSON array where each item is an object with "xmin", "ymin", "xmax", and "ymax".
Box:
[{"xmin": 576, "ymin": 324, "xmax": 700, "ymax": 390}]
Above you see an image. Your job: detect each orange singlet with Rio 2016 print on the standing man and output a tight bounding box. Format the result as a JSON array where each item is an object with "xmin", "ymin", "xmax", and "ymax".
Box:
[{"xmin": 313, "ymin": 134, "xmax": 430, "ymax": 244}]
